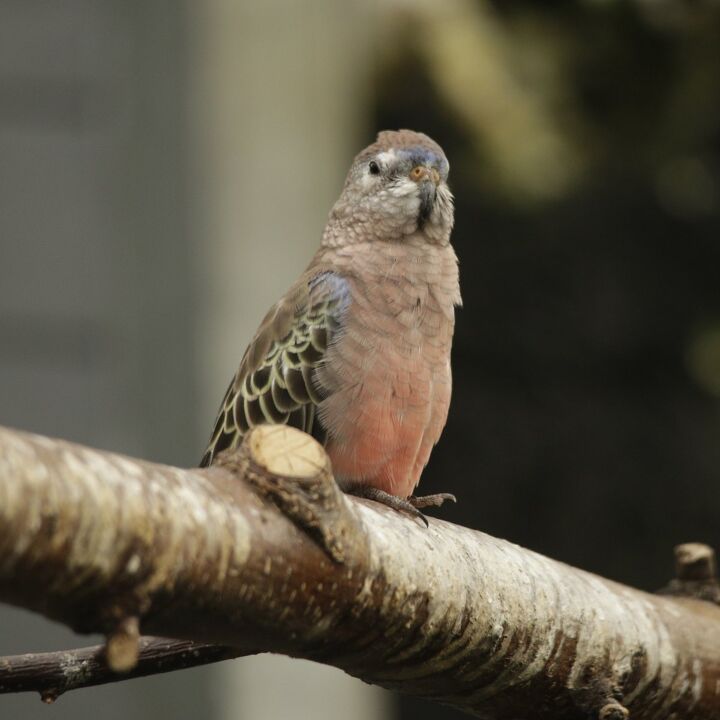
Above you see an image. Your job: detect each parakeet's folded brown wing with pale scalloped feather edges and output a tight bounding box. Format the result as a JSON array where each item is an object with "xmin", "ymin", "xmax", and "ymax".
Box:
[{"xmin": 200, "ymin": 270, "xmax": 350, "ymax": 467}]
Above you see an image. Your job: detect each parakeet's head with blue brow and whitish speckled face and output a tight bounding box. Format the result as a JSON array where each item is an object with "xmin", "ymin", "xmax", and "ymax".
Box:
[{"xmin": 330, "ymin": 130, "xmax": 453, "ymax": 244}]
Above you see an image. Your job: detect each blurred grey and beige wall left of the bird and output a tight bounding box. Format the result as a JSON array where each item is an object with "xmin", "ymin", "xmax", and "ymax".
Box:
[{"xmin": 0, "ymin": 0, "xmax": 390, "ymax": 720}]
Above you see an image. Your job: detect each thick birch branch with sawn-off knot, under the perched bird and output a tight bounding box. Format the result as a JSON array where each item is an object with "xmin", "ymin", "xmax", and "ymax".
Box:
[{"xmin": 0, "ymin": 427, "xmax": 720, "ymax": 720}]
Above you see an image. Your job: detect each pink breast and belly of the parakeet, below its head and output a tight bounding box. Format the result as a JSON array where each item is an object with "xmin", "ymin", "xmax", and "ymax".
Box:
[{"xmin": 318, "ymin": 237, "xmax": 460, "ymax": 497}]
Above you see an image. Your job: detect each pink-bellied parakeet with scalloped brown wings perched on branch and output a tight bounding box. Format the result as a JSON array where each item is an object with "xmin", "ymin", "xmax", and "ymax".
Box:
[{"xmin": 200, "ymin": 130, "xmax": 462, "ymax": 525}]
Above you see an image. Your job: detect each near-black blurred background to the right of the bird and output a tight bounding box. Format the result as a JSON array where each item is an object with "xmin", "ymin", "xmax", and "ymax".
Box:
[{"xmin": 376, "ymin": 2, "xmax": 720, "ymax": 718}]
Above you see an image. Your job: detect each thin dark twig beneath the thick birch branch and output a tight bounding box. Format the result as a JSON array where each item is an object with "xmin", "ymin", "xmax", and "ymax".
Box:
[{"xmin": 0, "ymin": 637, "xmax": 243, "ymax": 703}]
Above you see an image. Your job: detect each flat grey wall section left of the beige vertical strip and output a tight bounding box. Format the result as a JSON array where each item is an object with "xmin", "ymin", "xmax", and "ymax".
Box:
[{"xmin": 0, "ymin": 0, "xmax": 209, "ymax": 720}]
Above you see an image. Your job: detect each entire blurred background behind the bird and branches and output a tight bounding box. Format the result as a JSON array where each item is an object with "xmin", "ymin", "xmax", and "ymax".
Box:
[{"xmin": 0, "ymin": 0, "xmax": 720, "ymax": 720}]
